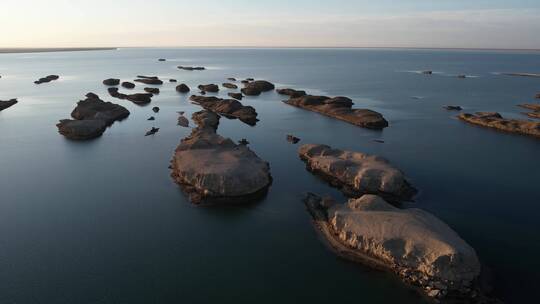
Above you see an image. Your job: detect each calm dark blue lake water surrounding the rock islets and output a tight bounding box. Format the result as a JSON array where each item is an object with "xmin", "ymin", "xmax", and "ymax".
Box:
[{"xmin": 0, "ymin": 49, "xmax": 540, "ymax": 303}]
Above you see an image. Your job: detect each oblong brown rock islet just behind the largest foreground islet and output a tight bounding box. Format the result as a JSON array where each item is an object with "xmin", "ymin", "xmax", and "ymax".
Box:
[{"xmin": 298, "ymin": 144, "xmax": 417, "ymax": 202}]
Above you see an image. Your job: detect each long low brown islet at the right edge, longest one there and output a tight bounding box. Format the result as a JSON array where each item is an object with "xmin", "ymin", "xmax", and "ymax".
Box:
[{"xmin": 458, "ymin": 112, "xmax": 540, "ymax": 137}]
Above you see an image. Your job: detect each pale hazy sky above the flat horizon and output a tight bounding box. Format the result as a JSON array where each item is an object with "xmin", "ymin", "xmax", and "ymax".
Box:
[{"xmin": 0, "ymin": 0, "xmax": 540, "ymax": 49}]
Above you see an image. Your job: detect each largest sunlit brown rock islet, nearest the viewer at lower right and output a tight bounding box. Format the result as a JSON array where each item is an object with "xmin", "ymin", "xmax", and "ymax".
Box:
[{"xmin": 304, "ymin": 194, "xmax": 480, "ymax": 303}]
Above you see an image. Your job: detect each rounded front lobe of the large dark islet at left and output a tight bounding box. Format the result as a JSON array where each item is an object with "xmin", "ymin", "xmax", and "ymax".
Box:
[{"xmin": 56, "ymin": 119, "xmax": 107, "ymax": 140}]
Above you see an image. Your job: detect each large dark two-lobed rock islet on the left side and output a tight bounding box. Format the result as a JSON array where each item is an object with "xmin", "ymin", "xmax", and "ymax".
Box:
[{"xmin": 56, "ymin": 93, "xmax": 130, "ymax": 140}]
